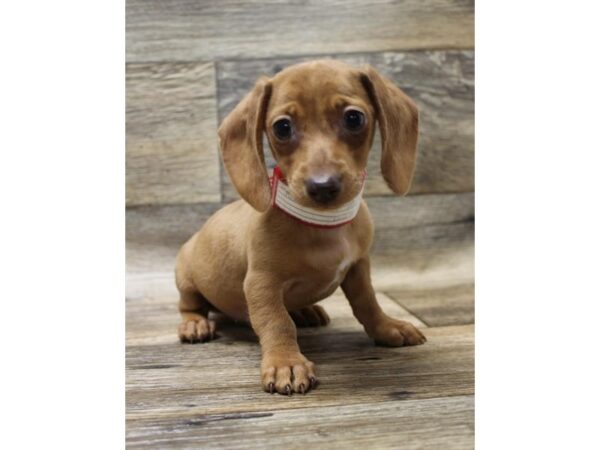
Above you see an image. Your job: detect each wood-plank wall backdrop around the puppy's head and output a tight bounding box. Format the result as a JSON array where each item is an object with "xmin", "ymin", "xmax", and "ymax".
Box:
[{"xmin": 126, "ymin": 0, "xmax": 474, "ymax": 211}]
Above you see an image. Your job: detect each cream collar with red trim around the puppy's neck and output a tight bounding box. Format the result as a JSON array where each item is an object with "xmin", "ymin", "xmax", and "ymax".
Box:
[{"xmin": 271, "ymin": 167, "xmax": 366, "ymax": 228}]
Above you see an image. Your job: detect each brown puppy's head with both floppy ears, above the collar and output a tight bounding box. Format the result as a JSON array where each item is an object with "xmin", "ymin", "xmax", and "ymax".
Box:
[{"xmin": 219, "ymin": 60, "xmax": 419, "ymax": 211}]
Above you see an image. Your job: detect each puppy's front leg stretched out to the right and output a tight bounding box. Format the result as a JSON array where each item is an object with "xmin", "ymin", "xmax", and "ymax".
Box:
[{"xmin": 342, "ymin": 256, "xmax": 426, "ymax": 347}]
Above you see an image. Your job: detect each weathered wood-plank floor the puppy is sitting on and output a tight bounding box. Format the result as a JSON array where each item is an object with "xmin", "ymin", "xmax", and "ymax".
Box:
[{"xmin": 126, "ymin": 209, "xmax": 474, "ymax": 449}]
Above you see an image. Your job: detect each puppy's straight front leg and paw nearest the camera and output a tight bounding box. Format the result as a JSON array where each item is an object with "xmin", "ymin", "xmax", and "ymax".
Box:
[{"xmin": 244, "ymin": 272, "xmax": 317, "ymax": 395}]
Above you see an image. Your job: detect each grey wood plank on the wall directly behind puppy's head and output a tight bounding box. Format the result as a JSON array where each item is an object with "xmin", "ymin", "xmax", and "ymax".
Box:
[{"xmin": 217, "ymin": 51, "xmax": 474, "ymax": 200}]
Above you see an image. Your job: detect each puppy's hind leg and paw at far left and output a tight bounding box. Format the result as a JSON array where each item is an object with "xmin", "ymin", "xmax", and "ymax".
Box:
[{"xmin": 178, "ymin": 287, "xmax": 216, "ymax": 344}]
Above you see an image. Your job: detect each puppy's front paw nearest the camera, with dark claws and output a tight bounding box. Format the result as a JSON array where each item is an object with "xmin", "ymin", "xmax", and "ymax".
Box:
[{"xmin": 261, "ymin": 352, "xmax": 317, "ymax": 395}]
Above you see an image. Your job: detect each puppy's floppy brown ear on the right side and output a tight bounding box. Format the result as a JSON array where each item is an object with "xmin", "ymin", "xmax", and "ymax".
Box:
[{"xmin": 360, "ymin": 66, "xmax": 419, "ymax": 195}]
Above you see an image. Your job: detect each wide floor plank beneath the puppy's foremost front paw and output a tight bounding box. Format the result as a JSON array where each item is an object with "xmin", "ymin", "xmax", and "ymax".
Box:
[{"xmin": 126, "ymin": 324, "xmax": 474, "ymax": 419}]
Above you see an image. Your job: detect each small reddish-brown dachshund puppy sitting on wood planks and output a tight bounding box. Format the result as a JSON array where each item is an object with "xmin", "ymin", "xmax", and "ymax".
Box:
[{"xmin": 176, "ymin": 60, "xmax": 425, "ymax": 395}]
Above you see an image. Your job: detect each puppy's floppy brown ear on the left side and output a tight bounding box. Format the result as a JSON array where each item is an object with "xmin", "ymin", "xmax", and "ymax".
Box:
[{"xmin": 218, "ymin": 77, "xmax": 271, "ymax": 211}]
